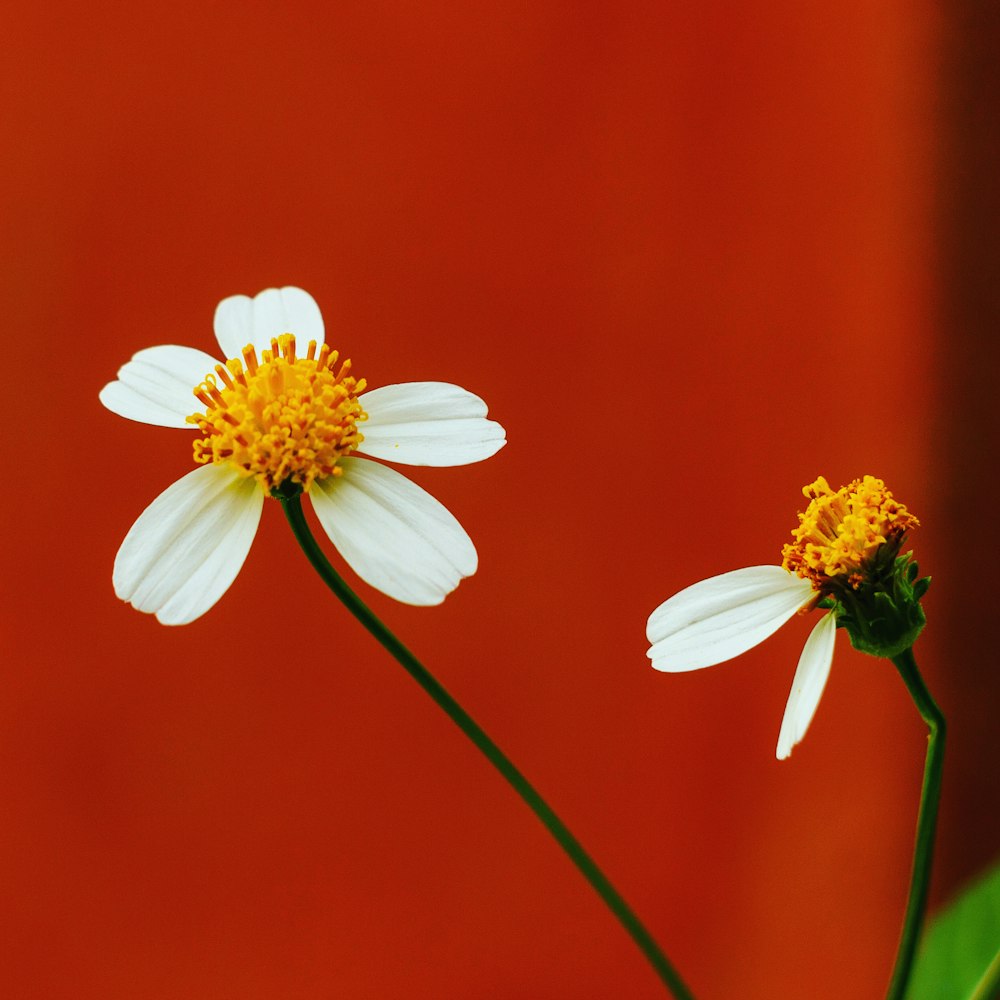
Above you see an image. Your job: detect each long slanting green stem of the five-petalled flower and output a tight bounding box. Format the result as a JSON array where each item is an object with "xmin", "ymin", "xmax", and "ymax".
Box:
[{"xmin": 277, "ymin": 495, "xmax": 694, "ymax": 1000}]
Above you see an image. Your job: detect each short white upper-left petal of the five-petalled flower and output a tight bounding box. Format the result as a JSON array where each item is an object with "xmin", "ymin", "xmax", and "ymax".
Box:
[{"xmin": 100, "ymin": 344, "xmax": 216, "ymax": 428}]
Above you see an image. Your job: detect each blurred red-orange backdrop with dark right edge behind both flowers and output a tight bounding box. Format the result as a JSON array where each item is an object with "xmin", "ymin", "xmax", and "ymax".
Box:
[{"xmin": 0, "ymin": 0, "xmax": 1000, "ymax": 1000}]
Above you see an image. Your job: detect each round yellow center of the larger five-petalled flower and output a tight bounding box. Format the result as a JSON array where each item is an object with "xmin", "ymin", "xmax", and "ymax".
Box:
[{"xmin": 187, "ymin": 333, "xmax": 367, "ymax": 491}]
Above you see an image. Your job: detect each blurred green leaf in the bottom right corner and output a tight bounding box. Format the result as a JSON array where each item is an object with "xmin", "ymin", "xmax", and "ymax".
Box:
[{"xmin": 906, "ymin": 865, "xmax": 1000, "ymax": 1000}]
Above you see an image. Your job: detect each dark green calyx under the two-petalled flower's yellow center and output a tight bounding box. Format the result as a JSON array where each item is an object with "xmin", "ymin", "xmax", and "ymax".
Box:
[{"xmin": 821, "ymin": 545, "xmax": 931, "ymax": 659}]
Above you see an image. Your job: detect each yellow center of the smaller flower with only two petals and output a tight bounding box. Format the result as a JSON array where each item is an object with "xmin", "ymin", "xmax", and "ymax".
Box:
[{"xmin": 782, "ymin": 476, "xmax": 920, "ymax": 591}]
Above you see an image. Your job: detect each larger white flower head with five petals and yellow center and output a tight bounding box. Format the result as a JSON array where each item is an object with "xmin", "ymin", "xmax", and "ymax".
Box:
[{"xmin": 100, "ymin": 287, "xmax": 506, "ymax": 625}]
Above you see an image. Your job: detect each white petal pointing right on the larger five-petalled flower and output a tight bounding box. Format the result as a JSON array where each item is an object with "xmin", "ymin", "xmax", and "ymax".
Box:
[{"xmin": 359, "ymin": 382, "xmax": 507, "ymax": 466}]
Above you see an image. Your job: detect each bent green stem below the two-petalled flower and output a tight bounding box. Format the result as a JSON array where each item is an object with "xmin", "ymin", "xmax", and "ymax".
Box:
[{"xmin": 886, "ymin": 648, "xmax": 945, "ymax": 1000}]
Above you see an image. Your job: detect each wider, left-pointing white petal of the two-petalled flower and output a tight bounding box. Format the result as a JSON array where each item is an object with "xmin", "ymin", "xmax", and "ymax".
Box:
[{"xmin": 646, "ymin": 566, "xmax": 813, "ymax": 672}]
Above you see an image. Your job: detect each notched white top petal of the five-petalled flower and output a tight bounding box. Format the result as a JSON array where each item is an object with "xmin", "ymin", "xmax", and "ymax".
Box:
[{"xmin": 215, "ymin": 285, "xmax": 324, "ymax": 358}]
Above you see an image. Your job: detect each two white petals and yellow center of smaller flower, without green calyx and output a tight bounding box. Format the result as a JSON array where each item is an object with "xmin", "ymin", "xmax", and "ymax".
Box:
[{"xmin": 646, "ymin": 476, "xmax": 917, "ymax": 760}]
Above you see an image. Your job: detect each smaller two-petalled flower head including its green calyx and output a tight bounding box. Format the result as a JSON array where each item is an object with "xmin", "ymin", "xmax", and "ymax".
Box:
[{"xmin": 646, "ymin": 476, "xmax": 927, "ymax": 760}]
